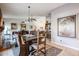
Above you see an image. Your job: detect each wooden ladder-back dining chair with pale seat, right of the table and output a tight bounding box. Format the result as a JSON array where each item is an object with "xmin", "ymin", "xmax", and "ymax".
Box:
[{"xmin": 31, "ymin": 31, "xmax": 46, "ymax": 56}]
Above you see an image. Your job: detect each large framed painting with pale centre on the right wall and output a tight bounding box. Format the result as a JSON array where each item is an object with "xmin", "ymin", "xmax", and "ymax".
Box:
[{"xmin": 57, "ymin": 15, "xmax": 76, "ymax": 38}]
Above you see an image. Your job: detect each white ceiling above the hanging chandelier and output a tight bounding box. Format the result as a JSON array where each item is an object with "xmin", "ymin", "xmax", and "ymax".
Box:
[{"xmin": 0, "ymin": 3, "xmax": 65, "ymax": 18}]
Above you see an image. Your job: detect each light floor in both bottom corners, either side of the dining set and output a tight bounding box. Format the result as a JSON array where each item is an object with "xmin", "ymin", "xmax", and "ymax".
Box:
[{"xmin": 2, "ymin": 41, "xmax": 79, "ymax": 56}]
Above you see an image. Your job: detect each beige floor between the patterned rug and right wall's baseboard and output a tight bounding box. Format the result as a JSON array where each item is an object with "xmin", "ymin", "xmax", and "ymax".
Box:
[{"xmin": 47, "ymin": 42, "xmax": 79, "ymax": 56}]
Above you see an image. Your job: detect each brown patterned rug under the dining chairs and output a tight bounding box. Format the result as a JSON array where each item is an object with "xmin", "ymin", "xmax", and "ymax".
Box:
[{"xmin": 32, "ymin": 45, "xmax": 62, "ymax": 56}]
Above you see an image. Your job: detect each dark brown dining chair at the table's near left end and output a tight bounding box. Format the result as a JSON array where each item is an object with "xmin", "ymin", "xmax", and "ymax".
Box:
[{"xmin": 19, "ymin": 35, "xmax": 32, "ymax": 56}]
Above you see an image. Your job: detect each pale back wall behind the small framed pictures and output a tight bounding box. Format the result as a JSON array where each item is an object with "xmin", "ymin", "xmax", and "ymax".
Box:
[{"xmin": 4, "ymin": 16, "xmax": 46, "ymax": 33}]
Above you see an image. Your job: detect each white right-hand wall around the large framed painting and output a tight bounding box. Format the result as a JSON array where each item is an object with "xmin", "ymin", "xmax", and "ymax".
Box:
[{"xmin": 51, "ymin": 3, "xmax": 79, "ymax": 50}]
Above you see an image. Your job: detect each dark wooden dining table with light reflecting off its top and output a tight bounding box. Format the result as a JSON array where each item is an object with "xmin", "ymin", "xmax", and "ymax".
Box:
[{"xmin": 23, "ymin": 34, "xmax": 37, "ymax": 56}]
